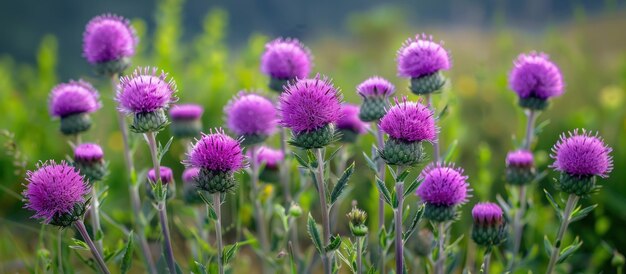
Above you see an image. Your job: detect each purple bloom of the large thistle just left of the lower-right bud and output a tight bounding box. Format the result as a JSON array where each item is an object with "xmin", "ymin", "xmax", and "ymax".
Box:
[{"xmin": 417, "ymin": 163, "xmax": 470, "ymax": 206}]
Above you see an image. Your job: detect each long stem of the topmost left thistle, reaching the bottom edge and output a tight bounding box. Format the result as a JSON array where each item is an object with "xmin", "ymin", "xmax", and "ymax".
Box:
[{"xmin": 111, "ymin": 74, "xmax": 157, "ymax": 274}]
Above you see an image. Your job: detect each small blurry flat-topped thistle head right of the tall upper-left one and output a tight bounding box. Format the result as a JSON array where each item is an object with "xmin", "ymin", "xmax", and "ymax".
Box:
[{"xmin": 170, "ymin": 104, "xmax": 204, "ymax": 138}]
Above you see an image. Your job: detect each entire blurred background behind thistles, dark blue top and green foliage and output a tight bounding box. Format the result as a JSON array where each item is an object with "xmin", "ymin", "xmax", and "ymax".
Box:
[{"xmin": 0, "ymin": 0, "xmax": 626, "ymax": 273}]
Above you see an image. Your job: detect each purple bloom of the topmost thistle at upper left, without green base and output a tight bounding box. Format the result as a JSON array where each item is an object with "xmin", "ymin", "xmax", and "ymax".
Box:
[{"xmin": 83, "ymin": 14, "xmax": 139, "ymax": 64}]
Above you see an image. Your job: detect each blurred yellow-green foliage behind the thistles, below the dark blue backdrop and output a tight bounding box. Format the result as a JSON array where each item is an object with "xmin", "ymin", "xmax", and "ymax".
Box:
[{"xmin": 0, "ymin": 0, "xmax": 626, "ymax": 273}]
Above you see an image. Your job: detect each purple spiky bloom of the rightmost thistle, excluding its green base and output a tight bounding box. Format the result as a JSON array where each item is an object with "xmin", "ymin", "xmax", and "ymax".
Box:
[{"xmin": 550, "ymin": 129, "xmax": 613, "ymax": 178}]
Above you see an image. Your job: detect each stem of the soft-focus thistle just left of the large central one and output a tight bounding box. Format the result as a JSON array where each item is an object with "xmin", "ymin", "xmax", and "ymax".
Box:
[{"xmin": 248, "ymin": 146, "xmax": 270, "ymax": 273}]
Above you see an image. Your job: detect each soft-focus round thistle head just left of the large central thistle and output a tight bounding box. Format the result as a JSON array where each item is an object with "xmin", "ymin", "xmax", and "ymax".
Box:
[{"xmin": 224, "ymin": 92, "xmax": 277, "ymax": 145}]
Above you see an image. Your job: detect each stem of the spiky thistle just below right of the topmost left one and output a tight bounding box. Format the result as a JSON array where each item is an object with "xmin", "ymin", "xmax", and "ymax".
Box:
[{"xmin": 146, "ymin": 132, "xmax": 176, "ymax": 274}]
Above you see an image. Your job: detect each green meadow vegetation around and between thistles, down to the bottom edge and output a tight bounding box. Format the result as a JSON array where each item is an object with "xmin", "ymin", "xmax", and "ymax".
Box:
[{"xmin": 0, "ymin": 0, "xmax": 626, "ymax": 273}]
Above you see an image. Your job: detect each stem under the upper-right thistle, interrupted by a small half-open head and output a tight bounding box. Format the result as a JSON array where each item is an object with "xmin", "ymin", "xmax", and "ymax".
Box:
[{"xmin": 509, "ymin": 110, "xmax": 537, "ymax": 271}]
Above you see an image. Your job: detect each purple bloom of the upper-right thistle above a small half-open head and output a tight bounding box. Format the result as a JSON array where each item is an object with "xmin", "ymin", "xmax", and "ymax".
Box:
[{"xmin": 509, "ymin": 52, "xmax": 563, "ymax": 100}]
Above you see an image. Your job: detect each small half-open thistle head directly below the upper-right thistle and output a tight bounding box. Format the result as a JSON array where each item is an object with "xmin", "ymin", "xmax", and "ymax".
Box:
[{"xmin": 506, "ymin": 149, "xmax": 535, "ymax": 185}]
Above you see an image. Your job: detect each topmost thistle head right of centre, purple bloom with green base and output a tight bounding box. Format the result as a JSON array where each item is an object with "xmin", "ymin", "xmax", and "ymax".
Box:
[{"xmin": 397, "ymin": 34, "xmax": 451, "ymax": 95}]
